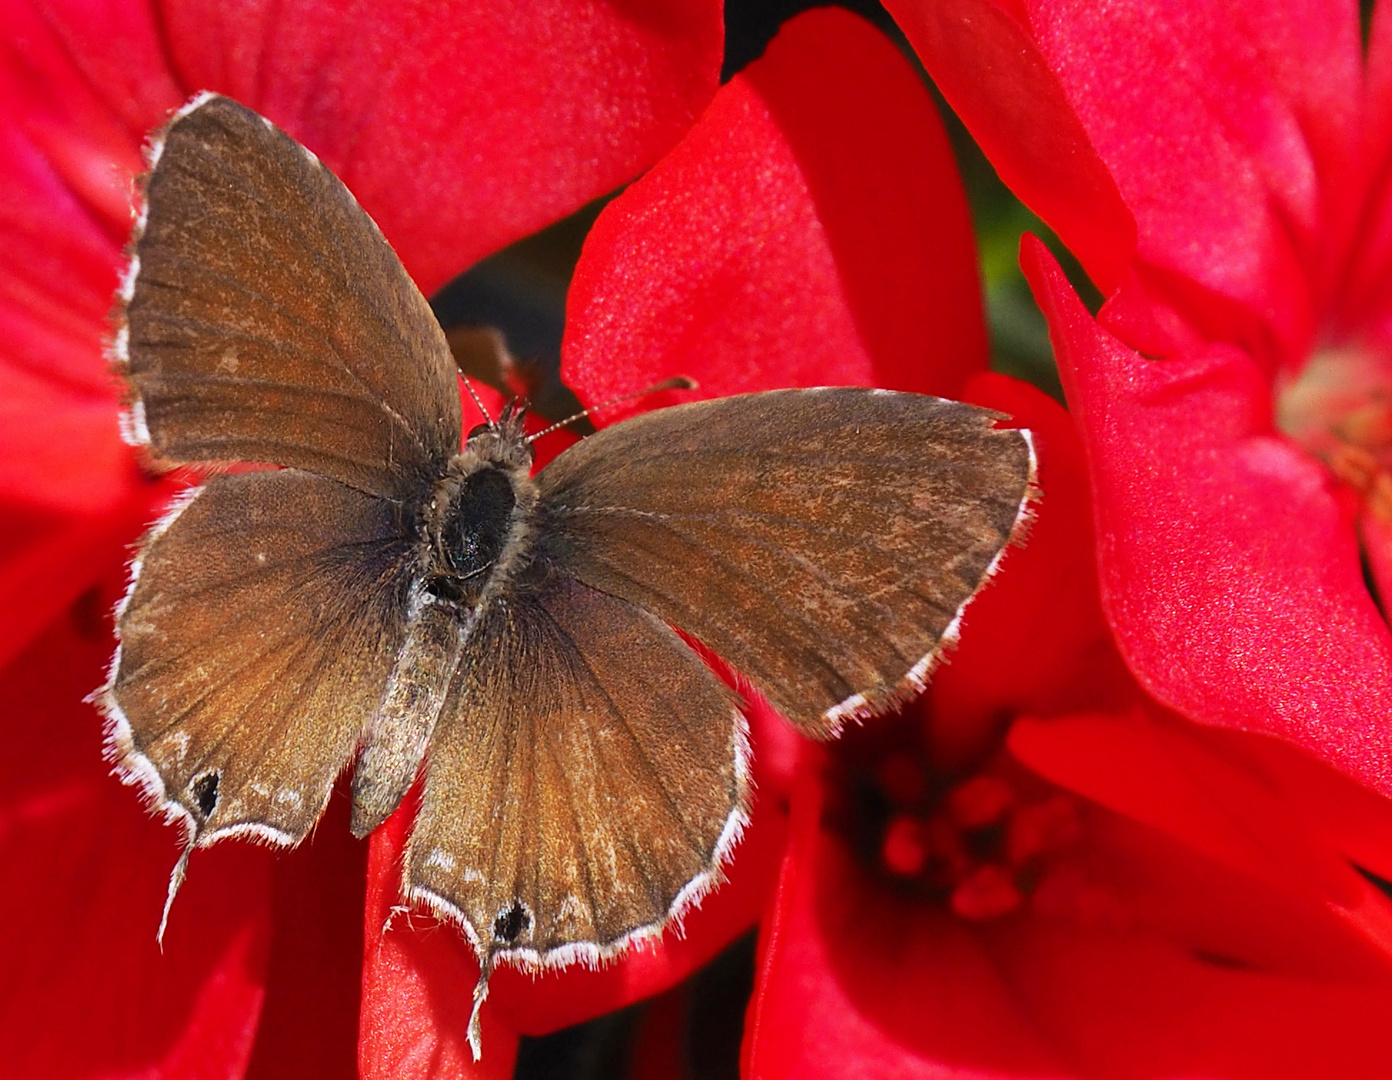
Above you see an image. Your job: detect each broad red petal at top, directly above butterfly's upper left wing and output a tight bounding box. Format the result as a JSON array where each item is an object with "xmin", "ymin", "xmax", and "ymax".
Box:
[{"xmin": 155, "ymin": 0, "xmax": 722, "ymax": 294}]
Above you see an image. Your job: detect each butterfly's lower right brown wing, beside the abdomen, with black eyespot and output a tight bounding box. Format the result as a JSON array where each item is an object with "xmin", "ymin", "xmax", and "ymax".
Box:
[{"xmin": 405, "ymin": 575, "xmax": 748, "ymax": 971}]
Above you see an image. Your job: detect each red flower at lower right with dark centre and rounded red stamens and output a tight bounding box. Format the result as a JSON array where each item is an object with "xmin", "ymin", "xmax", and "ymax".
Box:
[{"xmin": 743, "ymin": 376, "xmax": 1392, "ymax": 1080}]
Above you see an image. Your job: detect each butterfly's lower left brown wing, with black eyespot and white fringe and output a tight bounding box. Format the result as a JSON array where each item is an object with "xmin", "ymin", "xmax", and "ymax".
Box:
[{"xmin": 103, "ymin": 469, "xmax": 413, "ymax": 845}]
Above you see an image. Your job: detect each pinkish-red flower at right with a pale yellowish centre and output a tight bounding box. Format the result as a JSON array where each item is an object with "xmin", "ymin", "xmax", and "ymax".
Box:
[{"xmin": 889, "ymin": 0, "xmax": 1392, "ymax": 795}]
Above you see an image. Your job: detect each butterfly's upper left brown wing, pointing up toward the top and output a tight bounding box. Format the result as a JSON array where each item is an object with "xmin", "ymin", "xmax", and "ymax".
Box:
[{"xmin": 111, "ymin": 95, "xmax": 459, "ymax": 498}]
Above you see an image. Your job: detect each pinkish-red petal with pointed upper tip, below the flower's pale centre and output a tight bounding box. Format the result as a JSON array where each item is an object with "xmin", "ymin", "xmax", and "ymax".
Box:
[{"xmin": 1022, "ymin": 238, "xmax": 1392, "ymax": 793}]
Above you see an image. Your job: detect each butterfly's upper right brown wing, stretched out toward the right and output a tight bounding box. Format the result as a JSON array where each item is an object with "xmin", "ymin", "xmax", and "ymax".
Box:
[{"xmin": 537, "ymin": 387, "xmax": 1034, "ymax": 735}]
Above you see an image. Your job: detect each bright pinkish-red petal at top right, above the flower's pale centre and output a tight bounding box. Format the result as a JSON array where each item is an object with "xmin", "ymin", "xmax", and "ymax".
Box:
[{"xmin": 1030, "ymin": 0, "xmax": 1363, "ymax": 360}]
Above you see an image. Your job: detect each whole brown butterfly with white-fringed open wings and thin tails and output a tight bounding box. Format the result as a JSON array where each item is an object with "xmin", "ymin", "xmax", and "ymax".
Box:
[{"xmin": 100, "ymin": 93, "xmax": 1034, "ymax": 1054}]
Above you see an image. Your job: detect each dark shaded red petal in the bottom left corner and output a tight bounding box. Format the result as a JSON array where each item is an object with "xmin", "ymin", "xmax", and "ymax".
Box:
[{"xmin": 0, "ymin": 610, "xmax": 270, "ymax": 1080}]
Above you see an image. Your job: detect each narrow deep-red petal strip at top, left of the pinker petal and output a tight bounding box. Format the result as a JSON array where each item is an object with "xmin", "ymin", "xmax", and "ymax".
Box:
[{"xmin": 885, "ymin": 0, "xmax": 1136, "ymax": 292}]
